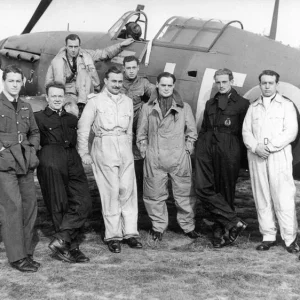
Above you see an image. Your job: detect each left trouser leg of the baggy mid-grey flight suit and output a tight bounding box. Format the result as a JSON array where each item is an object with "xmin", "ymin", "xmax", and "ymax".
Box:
[{"xmin": 143, "ymin": 163, "xmax": 169, "ymax": 232}]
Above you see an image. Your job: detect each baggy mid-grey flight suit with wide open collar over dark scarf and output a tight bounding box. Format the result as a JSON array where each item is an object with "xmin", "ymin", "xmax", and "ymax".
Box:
[{"xmin": 137, "ymin": 90, "xmax": 197, "ymax": 233}]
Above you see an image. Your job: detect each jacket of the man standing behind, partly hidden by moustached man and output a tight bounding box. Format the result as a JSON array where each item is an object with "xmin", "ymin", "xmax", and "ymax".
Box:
[{"xmin": 121, "ymin": 74, "xmax": 155, "ymax": 112}]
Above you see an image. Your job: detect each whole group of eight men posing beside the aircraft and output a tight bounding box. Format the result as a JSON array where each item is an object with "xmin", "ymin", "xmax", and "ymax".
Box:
[{"xmin": 0, "ymin": 34, "xmax": 299, "ymax": 272}]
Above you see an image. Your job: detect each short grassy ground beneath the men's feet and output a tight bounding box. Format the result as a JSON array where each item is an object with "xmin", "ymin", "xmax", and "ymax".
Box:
[{"xmin": 0, "ymin": 173, "xmax": 300, "ymax": 300}]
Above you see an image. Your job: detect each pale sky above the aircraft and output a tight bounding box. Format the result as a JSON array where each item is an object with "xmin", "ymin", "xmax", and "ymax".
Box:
[{"xmin": 0, "ymin": 0, "xmax": 300, "ymax": 48}]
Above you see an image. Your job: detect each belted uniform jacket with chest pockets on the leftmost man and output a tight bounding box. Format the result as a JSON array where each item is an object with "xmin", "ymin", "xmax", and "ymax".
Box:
[{"xmin": 0, "ymin": 93, "xmax": 40, "ymax": 174}]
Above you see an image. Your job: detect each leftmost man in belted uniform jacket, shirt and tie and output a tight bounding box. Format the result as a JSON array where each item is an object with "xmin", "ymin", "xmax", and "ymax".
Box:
[{"xmin": 0, "ymin": 65, "xmax": 40, "ymax": 272}]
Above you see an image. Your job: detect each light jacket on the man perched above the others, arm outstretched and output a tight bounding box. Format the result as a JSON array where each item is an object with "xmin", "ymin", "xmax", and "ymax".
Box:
[{"xmin": 45, "ymin": 44, "xmax": 122, "ymax": 95}]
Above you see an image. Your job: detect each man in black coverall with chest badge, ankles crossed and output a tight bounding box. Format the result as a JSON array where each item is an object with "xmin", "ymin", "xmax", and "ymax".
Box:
[{"xmin": 195, "ymin": 69, "xmax": 249, "ymax": 248}]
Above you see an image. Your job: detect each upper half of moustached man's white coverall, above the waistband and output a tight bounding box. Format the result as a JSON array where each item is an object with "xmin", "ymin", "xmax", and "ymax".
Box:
[{"xmin": 78, "ymin": 88, "xmax": 133, "ymax": 156}]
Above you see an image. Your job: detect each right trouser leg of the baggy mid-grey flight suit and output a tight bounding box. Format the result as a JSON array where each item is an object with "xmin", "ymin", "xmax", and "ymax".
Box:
[{"xmin": 170, "ymin": 153, "xmax": 196, "ymax": 233}]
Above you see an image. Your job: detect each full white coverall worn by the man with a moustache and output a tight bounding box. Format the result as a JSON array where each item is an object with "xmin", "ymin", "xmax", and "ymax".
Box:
[{"xmin": 78, "ymin": 89, "xmax": 139, "ymax": 241}]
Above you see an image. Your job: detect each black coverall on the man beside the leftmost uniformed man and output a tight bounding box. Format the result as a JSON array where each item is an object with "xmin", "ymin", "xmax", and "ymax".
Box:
[{"xmin": 35, "ymin": 107, "xmax": 92, "ymax": 249}]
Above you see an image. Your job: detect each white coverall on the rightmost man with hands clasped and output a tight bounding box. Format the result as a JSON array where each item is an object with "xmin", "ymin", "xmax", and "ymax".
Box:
[{"xmin": 243, "ymin": 93, "xmax": 298, "ymax": 246}]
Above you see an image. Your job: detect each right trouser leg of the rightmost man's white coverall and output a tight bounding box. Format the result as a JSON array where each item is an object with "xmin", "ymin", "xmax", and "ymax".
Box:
[{"xmin": 268, "ymin": 147, "xmax": 298, "ymax": 246}]
